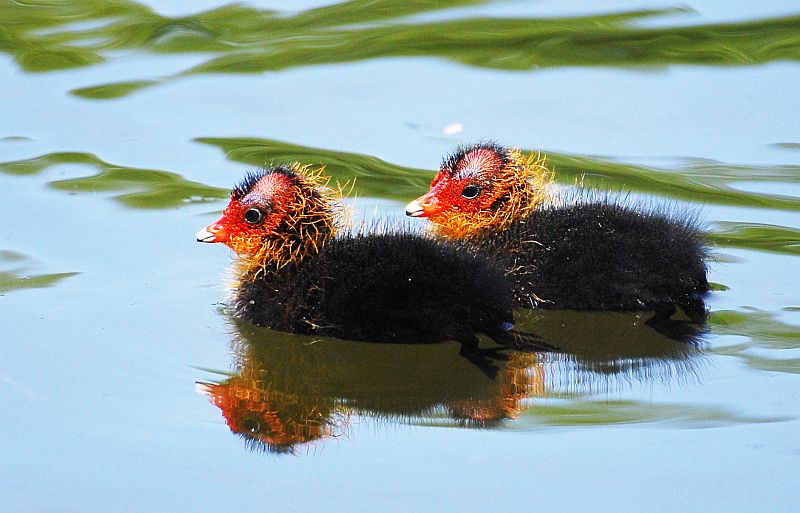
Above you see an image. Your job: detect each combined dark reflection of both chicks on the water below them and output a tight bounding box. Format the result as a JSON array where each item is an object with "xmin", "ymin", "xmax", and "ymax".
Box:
[{"xmin": 197, "ymin": 311, "xmax": 701, "ymax": 453}]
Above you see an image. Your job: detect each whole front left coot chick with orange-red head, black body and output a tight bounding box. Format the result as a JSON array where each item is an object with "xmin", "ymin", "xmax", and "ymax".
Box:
[{"xmin": 197, "ymin": 164, "xmax": 513, "ymax": 365}]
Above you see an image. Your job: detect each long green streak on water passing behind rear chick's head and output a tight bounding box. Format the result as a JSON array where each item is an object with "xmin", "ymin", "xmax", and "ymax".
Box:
[{"xmin": 195, "ymin": 137, "xmax": 800, "ymax": 211}]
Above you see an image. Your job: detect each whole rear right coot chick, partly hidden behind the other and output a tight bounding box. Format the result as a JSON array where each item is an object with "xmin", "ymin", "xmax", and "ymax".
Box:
[{"xmin": 406, "ymin": 143, "xmax": 709, "ymax": 321}]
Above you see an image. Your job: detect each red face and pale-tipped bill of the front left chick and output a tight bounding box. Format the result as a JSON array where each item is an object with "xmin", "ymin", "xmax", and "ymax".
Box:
[{"xmin": 197, "ymin": 173, "xmax": 293, "ymax": 255}]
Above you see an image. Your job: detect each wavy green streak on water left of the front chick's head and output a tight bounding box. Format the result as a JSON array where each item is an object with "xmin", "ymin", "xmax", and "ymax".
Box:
[{"xmin": 0, "ymin": 152, "xmax": 229, "ymax": 209}]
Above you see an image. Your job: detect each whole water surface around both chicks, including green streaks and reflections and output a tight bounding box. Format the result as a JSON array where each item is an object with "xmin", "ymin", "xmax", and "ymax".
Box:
[{"xmin": 0, "ymin": 0, "xmax": 800, "ymax": 512}]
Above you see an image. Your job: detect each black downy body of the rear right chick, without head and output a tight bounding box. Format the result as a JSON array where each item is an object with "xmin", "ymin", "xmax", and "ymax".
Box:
[{"xmin": 480, "ymin": 199, "xmax": 709, "ymax": 320}]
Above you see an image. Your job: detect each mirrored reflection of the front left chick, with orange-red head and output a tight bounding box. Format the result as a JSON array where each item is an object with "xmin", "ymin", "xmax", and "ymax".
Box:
[{"xmin": 197, "ymin": 321, "xmax": 549, "ymax": 453}]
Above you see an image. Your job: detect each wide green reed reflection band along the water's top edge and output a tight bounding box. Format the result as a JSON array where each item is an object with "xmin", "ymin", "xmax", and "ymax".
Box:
[{"xmin": 0, "ymin": 0, "xmax": 800, "ymax": 99}]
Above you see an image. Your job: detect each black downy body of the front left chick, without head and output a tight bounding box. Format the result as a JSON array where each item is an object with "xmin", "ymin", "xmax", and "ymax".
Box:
[{"xmin": 233, "ymin": 232, "xmax": 513, "ymax": 345}]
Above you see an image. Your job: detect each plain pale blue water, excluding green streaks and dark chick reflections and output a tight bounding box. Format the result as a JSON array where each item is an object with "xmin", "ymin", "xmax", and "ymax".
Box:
[{"xmin": 0, "ymin": 0, "xmax": 800, "ymax": 513}]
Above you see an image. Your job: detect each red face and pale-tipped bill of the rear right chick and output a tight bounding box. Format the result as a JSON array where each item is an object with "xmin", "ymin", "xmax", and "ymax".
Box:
[{"xmin": 406, "ymin": 146, "xmax": 506, "ymax": 222}]
